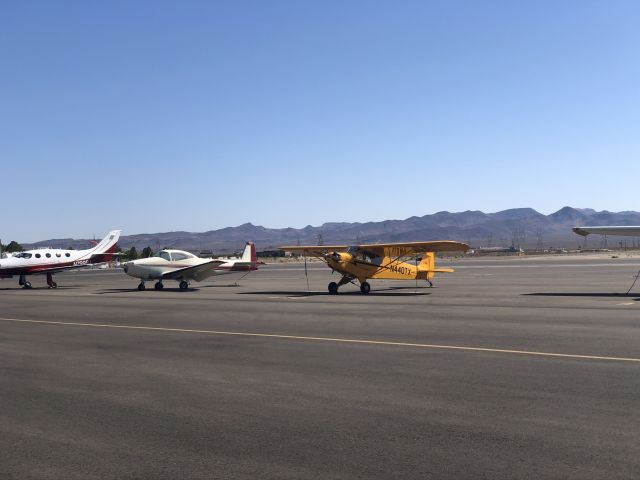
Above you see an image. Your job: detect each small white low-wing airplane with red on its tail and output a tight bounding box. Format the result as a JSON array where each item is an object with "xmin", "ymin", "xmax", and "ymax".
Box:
[{"xmin": 124, "ymin": 242, "xmax": 258, "ymax": 290}]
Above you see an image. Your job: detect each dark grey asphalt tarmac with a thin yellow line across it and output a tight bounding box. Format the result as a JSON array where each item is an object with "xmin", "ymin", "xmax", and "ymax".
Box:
[{"xmin": 0, "ymin": 257, "xmax": 640, "ymax": 480}]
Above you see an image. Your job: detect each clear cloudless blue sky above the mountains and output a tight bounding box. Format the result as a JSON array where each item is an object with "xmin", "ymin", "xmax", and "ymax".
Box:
[{"xmin": 0, "ymin": 0, "xmax": 640, "ymax": 242}]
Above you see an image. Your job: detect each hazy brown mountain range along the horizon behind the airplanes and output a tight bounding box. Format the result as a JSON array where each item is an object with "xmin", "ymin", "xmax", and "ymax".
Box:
[{"xmin": 25, "ymin": 207, "xmax": 640, "ymax": 253}]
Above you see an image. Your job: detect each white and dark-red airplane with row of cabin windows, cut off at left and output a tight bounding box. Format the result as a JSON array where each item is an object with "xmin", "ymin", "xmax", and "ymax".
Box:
[{"xmin": 0, "ymin": 230, "xmax": 122, "ymax": 288}]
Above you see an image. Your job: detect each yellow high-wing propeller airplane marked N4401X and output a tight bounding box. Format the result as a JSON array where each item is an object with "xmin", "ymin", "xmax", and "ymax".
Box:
[{"xmin": 280, "ymin": 240, "xmax": 469, "ymax": 295}]
